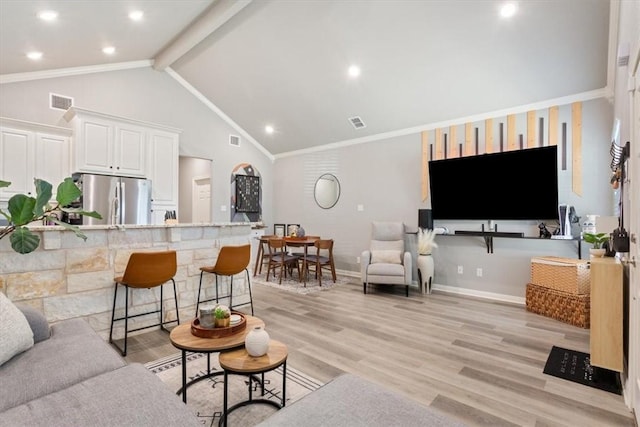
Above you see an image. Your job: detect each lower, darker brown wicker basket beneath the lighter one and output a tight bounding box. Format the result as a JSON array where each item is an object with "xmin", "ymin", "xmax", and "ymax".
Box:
[{"xmin": 526, "ymin": 283, "xmax": 591, "ymax": 329}]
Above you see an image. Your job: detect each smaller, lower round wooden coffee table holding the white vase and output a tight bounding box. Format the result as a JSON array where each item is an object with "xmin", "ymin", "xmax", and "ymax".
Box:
[{"xmin": 219, "ymin": 340, "xmax": 288, "ymax": 426}]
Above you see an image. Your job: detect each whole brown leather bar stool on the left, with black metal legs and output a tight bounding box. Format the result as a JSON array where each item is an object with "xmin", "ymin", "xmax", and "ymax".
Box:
[{"xmin": 109, "ymin": 251, "xmax": 180, "ymax": 356}]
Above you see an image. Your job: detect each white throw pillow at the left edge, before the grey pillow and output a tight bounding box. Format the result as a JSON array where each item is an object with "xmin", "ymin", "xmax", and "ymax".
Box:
[{"xmin": 0, "ymin": 292, "xmax": 33, "ymax": 365}]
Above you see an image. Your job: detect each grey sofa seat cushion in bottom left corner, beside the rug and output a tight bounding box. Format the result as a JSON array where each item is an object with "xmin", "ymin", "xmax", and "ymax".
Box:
[{"xmin": 0, "ymin": 363, "xmax": 202, "ymax": 427}]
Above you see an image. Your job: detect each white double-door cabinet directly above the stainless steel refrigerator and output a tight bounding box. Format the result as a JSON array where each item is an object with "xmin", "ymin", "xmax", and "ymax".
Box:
[{"xmin": 64, "ymin": 107, "xmax": 147, "ymax": 177}]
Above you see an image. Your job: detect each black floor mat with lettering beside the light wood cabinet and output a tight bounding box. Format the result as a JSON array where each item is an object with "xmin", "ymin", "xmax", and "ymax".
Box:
[{"xmin": 542, "ymin": 346, "xmax": 622, "ymax": 394}]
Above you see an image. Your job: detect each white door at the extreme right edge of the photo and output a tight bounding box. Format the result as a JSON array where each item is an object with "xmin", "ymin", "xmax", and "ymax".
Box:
[{"xmin": 625, "ymin": 62, "xmax": 640, "ymax": 425}]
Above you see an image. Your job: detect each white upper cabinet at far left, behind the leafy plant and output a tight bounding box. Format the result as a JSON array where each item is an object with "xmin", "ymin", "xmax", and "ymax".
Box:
[{"xmin": 0, "ymin": 118, "xmax": 71, "ymax": 200}]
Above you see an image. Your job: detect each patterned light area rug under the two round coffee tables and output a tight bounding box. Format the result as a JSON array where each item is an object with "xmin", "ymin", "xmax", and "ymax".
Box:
[{"xmin": 145, "ymin": 353, "xmax": 322, "ymax": 426}]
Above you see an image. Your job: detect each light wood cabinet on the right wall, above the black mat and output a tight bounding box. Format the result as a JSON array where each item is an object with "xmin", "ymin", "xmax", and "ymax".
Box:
[{"xmin": 590, "ymin": 258, "xmax": 624, "ymax": 372}]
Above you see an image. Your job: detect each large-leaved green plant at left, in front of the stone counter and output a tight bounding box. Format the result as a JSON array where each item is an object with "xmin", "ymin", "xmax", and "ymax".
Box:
[{"xmin": 0, "ymin": 178, "xmax": 102, "ymax": 254}]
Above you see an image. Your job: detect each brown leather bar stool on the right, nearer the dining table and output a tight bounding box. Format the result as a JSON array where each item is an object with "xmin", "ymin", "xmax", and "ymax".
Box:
[{"xmin": 196, "ymin": 244, "xmax": 253, "ymax": 317}]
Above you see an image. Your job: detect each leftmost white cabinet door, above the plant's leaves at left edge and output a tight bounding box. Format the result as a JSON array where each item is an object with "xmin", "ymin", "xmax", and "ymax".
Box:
[{"xmin": 0, "ymin": 127, "xmax": 35, "ymax": 200}]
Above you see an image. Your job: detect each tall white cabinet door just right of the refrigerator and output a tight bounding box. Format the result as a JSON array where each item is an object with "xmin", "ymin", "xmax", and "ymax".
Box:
[{"xmin": 147, "ymin": 129, "xmax": 179, "ymax": 206}]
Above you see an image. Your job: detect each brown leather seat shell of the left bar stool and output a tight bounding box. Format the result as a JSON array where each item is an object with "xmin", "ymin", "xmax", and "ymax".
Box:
[{"xmin": 121, "ymin": 251, "xmax": 178, "ymax": 288}]
